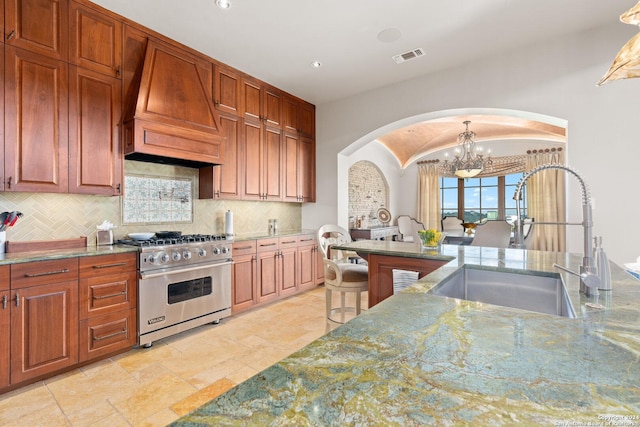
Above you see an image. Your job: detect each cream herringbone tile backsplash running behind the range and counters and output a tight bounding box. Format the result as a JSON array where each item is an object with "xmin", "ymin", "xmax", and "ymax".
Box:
[{"xmin": 0, "ymin": 160, "xmax": 302, "ymax": 245}]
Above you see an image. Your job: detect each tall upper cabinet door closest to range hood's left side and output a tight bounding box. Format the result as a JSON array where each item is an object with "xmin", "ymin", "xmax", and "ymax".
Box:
[{"xmin": 69, "ymin": 66, "xmax": 123, "ymax": 196}]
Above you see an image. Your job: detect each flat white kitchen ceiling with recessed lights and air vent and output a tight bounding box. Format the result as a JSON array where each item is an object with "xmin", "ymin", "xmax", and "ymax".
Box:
[{"xmin": 92, "ymin": 0, "xmax": 635, "ymax": 105}]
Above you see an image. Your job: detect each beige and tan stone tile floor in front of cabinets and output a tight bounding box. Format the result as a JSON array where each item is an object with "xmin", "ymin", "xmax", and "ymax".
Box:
[{"xmin": 0, "ymin": 287, "xmax": 366, "ymax": 427}]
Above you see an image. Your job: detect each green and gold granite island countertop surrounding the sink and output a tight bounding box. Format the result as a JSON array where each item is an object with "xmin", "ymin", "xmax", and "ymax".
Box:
[{"xmin": 175, "ymin": 246, "xmax": 640, "ymax": 426}]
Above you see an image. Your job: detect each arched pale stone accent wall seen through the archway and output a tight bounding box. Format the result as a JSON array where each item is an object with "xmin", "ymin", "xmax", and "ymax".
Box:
[{"xmin": 349, "ymin": 160, "xmax": 389, "ymax": 228}]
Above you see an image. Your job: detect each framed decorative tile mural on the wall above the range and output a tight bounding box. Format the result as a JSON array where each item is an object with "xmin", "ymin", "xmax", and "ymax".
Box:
[{"xmin": 122, "ymin": 175, "xmax": 194, "ymax": 224}]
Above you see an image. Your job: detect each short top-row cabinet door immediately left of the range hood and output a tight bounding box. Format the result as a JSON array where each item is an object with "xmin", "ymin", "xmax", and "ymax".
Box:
[{"xmin": 69, "ymin": 1, "xmax": 122, "ymax": 78}]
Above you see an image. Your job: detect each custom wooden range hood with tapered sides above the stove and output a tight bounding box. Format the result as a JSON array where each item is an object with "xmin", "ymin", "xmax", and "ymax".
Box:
[{"xmin": 124, "ymin": 39, "xmax": 224, "ymax": 168}]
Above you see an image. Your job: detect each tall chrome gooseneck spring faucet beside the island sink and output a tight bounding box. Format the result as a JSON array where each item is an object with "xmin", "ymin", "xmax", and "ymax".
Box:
[{"xmin": 513, "ymin": 164, "xmax": 600, "ymax": 296}]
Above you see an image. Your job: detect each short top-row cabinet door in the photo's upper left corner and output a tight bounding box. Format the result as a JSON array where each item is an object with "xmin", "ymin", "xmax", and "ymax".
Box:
[{"xmin": 4, "ymin": 0, "xmax": 69, "ymax": 61}]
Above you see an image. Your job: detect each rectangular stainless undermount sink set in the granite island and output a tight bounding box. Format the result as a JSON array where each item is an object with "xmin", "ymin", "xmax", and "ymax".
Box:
[{"xmin": 429, "ymin": 267, "xmax": 576, "ymax": 318}]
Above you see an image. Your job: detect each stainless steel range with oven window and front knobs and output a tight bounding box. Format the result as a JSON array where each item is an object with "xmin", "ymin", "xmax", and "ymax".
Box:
[{"xmin": 121, "ymin": 235, "xmax": 232, "ymax": 347}]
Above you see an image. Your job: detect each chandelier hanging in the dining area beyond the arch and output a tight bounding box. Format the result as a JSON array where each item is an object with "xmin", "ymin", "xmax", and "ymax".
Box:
[{"xmin": 442, "ymin": 120, "xmax": 493, "ymax": 178}]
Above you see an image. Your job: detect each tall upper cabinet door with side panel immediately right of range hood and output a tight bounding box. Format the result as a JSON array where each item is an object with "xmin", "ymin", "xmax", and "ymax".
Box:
[{"xmin": 198, "ymin": 114, "xmax": 244, "ymax": 200}]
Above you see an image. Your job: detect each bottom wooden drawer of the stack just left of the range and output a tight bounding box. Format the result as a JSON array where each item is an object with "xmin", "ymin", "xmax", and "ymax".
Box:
[{"xmin": 80, "ymin": 309, "xmax": 137, "ymax": 362}]
